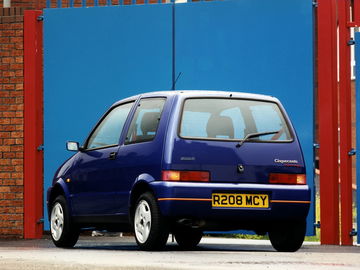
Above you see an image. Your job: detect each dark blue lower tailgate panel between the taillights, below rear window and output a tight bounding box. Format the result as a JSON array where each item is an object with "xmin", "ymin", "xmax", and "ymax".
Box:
[{"xmin": 167, "ymin": 139, "xmax": 305, "ymax": 183}]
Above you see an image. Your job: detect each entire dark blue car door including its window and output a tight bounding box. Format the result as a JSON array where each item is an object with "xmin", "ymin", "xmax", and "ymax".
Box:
[{"xmin": 71, "ymin": 102, "xmax": 134, "ymax": 216}]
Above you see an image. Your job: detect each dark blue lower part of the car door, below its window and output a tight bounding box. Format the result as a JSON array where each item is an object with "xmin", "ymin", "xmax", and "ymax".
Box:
[{"xmin": 69, "ymin": 146, "xmax": 123, "ymax": 215}]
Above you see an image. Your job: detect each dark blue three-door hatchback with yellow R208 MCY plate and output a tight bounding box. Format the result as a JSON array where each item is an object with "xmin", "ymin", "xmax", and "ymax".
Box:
[{"xmin": 47, "ymin": 91, "xmax": 310, "ymax": 252}]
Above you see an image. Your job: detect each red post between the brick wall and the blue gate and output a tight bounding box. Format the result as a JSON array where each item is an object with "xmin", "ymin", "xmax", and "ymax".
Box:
[{"xmin": 24, "ymin": 10, "xmax": 43, "ymax": 239}]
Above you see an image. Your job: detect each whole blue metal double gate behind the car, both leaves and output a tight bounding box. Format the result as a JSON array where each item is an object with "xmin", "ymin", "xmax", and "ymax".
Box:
[{"xmin": 44, "ymin": 0, "xmax": 314, "ymax": 234}]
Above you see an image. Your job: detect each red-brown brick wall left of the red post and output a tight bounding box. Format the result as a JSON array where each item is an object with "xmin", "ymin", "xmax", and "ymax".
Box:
[{"xmin": 0, "ymin": 8, "xmax": 24, "ymax": 238}]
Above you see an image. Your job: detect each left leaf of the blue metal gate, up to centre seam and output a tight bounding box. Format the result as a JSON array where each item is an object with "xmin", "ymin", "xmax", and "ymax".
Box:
[{"xmin": 44, "ymin": 5, "xmax": 172, "ymax": 229}]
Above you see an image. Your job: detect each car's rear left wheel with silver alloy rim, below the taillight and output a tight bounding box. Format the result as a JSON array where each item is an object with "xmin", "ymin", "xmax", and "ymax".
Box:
[{"xmin": 133, "ymin": 192, "xmax": 169, "ymax": 250}]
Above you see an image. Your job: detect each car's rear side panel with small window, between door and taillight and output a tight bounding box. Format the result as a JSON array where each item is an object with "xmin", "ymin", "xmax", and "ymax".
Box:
[{"xmin": 114, "ymin": 97, "xmax": 170, "ymax": 212}]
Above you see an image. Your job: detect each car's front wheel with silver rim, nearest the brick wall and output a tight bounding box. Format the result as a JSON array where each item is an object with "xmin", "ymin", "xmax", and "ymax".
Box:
[{"xmin": 50, "ymin": 196, "xmax": 80, "ymax": 248}]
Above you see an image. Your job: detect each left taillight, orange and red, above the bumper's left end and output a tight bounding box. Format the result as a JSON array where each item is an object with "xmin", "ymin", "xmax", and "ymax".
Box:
[{"xmin": 161, "ymin": 171, "xmax": 210, "ymax": 182}]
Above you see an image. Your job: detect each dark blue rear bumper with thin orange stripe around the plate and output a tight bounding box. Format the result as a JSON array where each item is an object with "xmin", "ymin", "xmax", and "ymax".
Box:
[{"xmin": 151, "ymin": 181, "xmax": 311, "ymax": 229}]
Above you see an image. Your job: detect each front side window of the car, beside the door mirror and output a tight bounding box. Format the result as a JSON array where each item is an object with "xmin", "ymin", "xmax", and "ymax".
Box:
[{"xmin": 86, "ymin": 102, "xmax": 134, "ymax": 149}]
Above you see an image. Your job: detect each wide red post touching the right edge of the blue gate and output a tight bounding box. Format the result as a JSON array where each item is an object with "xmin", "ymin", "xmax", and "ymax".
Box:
[{"xmin": 317, "ymin": 0, "xmax": 339, "ymax": 245}]
